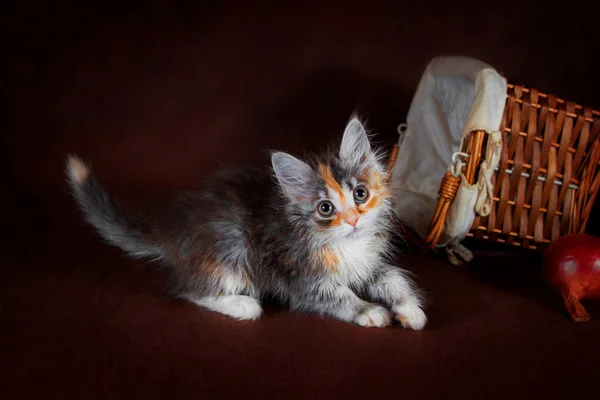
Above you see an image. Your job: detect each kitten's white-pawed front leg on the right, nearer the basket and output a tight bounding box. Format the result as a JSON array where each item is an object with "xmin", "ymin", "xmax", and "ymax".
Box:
[{"xmin": 367, "ymin": 264, "xmax": 427, "ymax": 330}]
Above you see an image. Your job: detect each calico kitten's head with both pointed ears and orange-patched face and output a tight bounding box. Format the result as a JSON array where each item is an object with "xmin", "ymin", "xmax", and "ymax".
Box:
[{"xmin": 272, "ymin": 118, "xmax": 391, "ymax": 243}]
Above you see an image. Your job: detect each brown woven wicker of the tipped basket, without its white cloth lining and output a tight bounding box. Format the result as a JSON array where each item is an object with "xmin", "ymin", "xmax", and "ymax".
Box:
[{"xmin": 420, "ymin": 84, "xmax": 600, "ymax": 250}]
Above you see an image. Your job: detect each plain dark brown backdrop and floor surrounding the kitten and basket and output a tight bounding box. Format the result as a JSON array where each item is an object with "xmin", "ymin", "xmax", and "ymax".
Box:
[{"xmin": 0, "ymin": 1, "xmax": 600, "ymax": 399}]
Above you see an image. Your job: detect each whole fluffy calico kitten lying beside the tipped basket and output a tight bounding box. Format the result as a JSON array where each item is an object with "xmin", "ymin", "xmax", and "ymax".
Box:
[{"xmin": 67, "ymin": 117, "xmax": 426, "ymax": 330}]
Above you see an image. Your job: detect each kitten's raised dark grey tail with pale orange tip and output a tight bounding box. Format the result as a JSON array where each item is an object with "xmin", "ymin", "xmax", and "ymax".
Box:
[{"xmin": 66, "ymin": 156, "xmax": 162, "ymax": 258}]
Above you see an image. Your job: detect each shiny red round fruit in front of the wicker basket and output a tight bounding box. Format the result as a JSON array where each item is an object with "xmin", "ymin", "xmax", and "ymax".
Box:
[{"xmin": 542, "ymin": 233, "xmax": 600, "ymax": 322}]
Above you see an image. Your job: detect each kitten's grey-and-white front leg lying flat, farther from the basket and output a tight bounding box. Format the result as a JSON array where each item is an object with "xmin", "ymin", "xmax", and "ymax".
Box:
[{"xmin": 290, "ymin": 282, "xmax": 391, "ymax": 328}]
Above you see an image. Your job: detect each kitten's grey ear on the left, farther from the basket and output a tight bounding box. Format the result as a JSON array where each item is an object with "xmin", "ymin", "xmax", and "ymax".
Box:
[{"xmin": 271, "ymin": 152, "xmax": 315, "ymax": 201}]
